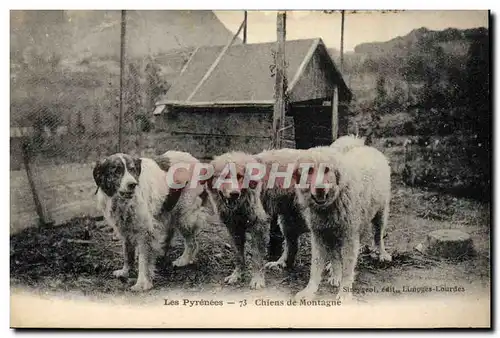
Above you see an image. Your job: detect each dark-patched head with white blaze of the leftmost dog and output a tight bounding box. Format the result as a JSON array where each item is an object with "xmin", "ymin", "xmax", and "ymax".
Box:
[{"xmin": 93, "ymin": 153, "xmax": 141, "ymax": 199}]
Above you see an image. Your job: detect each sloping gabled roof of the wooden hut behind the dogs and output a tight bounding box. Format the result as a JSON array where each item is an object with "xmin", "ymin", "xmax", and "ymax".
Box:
[{"xmin": 157, "ymin": 38, "xmax": 351, "ymax": 106}]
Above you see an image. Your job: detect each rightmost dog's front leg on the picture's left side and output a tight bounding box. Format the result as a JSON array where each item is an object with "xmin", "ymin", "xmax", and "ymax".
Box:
[{"xmin": 295, "ymin": 232, "xmax": 327, "ymax": 299}]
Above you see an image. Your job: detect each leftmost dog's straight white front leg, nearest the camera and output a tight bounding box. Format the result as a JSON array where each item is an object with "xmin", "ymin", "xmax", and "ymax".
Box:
[{"xmin": 131, "ymin": 234, "xmax": 154, "ymax": 291}]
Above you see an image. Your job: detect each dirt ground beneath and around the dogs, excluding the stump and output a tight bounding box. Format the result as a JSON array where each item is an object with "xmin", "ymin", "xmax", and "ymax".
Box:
[{"xmin": 10, "ymin": 177, "xmax": 490, "ymax": 302}]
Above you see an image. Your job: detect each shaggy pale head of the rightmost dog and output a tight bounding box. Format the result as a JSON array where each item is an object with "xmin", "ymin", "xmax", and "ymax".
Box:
[{"xmin": 294, "ymin": 154, "xmax": 345, "ymax": 208}]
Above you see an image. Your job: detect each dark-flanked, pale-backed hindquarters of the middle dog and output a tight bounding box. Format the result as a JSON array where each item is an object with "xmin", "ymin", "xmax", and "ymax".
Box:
[{"xmin": 255, "ymin": 148, "xmax": 309, "ymax": 269}]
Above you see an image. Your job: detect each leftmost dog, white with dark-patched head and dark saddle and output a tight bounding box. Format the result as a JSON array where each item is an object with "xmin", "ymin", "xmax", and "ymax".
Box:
[{"xmin": 93, "ymin": 153, "xmax": 204, "ymax": 291}]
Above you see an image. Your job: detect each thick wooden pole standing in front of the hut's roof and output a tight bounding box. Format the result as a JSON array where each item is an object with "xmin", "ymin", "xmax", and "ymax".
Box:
[{"xmin": 272, "ymin": 11, "xmax": 286, "ymax": 149}]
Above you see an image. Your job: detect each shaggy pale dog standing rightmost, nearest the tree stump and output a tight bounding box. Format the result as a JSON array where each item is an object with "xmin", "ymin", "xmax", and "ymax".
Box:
[{"xmin": 296, "ymin": 146, "xmax": 391, "ymax": 299}]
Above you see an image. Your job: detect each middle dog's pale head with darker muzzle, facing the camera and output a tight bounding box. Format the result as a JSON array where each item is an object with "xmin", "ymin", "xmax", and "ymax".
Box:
[{"xmin": 206, "ymin": 152, "xmax": 265, "ymax": 209}]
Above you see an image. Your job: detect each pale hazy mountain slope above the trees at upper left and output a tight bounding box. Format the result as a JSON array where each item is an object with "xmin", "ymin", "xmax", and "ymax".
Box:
[{"xmin": 10, "ymin": 10, "xmax": 241, "ymax": 59}]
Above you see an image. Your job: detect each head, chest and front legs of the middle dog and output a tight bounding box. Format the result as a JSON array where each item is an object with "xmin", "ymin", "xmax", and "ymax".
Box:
[{"xmin": 207, "ymin": 152, "xmax": 269, "ymax": 289}]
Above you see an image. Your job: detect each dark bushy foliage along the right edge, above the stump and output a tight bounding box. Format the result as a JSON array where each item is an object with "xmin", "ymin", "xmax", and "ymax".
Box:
[{"xmin": 346, "ymin": 29, "xmax": 491, "ymax": 201}]
